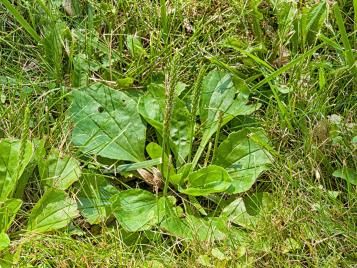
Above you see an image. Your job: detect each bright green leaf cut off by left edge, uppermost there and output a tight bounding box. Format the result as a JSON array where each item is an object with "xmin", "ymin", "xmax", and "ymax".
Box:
[{"xmin": 0, "ymin": 139, "xmax": 33, "ymax": 202}]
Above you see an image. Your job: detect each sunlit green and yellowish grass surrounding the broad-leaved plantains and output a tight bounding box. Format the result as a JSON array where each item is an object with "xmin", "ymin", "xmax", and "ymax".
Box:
[{"xmin": 0, "ymin": 0, "xmax": 357, "ymax": 267}]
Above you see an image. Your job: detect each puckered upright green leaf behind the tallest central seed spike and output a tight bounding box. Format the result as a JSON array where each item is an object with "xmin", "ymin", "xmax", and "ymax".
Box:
[{"xmin": 138, "ymin": 84, "xmax": 192, "ymax": 166}]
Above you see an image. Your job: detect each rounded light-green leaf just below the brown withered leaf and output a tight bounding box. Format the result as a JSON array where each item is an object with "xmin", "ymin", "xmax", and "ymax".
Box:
[{"xmin": 111, "ymin": 189, "xmax": 175, "ymax": 232}]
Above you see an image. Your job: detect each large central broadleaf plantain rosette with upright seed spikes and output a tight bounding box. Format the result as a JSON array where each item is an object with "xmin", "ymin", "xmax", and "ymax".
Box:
[{"xmin": 70, "ymin": 69, "xmax": 272, "ymax": 240}]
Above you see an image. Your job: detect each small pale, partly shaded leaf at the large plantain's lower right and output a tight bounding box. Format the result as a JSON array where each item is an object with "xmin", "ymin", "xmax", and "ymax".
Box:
[{"xmin": 221, "ymin": 193, "xmax": 272, "ymax": 229}]
